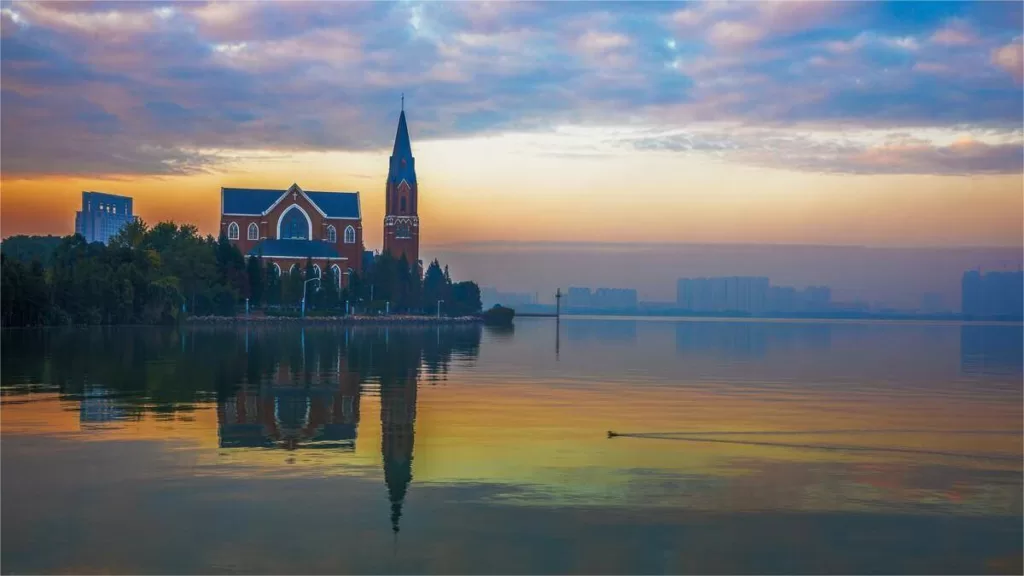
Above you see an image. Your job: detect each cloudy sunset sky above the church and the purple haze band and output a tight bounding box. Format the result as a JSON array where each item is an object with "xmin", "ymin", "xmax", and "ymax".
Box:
[{"xmin": 0, "ymin": 1, "xmax": 1024, "ymax": 249}]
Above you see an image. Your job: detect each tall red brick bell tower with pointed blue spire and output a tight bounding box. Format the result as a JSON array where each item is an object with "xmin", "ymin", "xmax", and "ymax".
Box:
[{"xmin": 384, "ymin": 95, "xmax": 422, "ymax": 271}]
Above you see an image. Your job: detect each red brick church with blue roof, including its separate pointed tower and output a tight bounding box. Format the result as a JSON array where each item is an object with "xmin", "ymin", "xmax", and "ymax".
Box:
[{"xmin": 220, "ymin": 107, "xmax": 422, "ymax": 286}]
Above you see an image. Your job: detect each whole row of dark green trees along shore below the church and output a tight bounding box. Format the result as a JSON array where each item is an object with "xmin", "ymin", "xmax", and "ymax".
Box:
[{"xmin": 0, "ymin": 219, "xmax": 480, "ymax": 326}]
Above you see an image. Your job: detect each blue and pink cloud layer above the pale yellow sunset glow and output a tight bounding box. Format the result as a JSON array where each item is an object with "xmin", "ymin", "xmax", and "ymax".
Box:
[{"xmin": 0, "ymin": 2, "xmax": 1022, "ymax": 174}]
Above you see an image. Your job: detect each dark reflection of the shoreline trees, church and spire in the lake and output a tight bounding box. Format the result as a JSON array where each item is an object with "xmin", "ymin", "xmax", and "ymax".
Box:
[{"xmin": 2, "ymin": 325, "xmax": 481, "ymax": 533}]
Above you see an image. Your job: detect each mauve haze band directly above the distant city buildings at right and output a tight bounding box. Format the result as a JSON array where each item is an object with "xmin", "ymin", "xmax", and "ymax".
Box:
[{"xmin": 436, "ymin": 243, "xmax": 1024, "ymax": 312}]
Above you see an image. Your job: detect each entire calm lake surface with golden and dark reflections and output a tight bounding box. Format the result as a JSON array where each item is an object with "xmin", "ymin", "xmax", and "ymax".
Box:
[{"xmin": 0, "ymin": 318, "xmax": 1024, "ymax": 574}]
